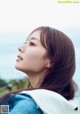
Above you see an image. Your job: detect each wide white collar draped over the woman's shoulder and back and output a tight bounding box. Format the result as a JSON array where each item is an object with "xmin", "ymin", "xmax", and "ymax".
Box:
[{"xmin": 20, "ymin": 89, "xmax": 80, "ymax": 114}]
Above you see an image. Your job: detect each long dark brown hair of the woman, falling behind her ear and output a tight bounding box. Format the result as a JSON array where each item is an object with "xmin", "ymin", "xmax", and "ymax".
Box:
[{"xmin": 0, "ymin": 26, "xmax": 75, "ymax": 100}]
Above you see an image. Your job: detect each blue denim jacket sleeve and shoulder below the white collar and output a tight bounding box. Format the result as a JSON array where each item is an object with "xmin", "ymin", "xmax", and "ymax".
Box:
[{"xmin": 9, "ymin": 94, "xmax": 43, "ymax": 114}]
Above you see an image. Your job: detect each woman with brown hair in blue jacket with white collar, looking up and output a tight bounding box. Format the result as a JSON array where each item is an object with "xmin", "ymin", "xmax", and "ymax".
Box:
[{"xmin": 0, "ymin": 26, "xmax": 80, "ymax": 114}]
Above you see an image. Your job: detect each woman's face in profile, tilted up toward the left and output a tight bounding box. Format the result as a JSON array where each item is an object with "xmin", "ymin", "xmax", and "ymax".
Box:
[{"xmin": 15, "ymin": 31, "xmax": 49, "ymax": 74}]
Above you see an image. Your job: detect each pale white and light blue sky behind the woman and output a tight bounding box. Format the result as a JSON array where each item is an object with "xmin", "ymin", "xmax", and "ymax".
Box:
[{"xmin": 0, "ymin": 0, "xmax": 80, "ymax": 84}]
